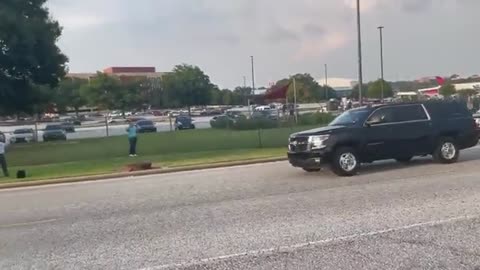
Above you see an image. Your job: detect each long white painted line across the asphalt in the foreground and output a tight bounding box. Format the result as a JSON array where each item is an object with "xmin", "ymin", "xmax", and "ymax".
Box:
[{"xmin": 138, "ymin": 215, "xmax": 480, "ymax": 270}]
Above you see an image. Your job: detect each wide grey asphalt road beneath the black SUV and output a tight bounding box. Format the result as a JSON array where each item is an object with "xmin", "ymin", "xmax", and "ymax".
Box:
[{"xmin": 0, "ymin": 148, "xmax": 480, "ymax": 270}]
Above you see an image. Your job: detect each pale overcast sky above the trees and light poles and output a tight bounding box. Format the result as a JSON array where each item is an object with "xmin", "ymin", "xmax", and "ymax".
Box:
[{"xmin": 48, "ymin": 0, "xmax": 480, "ymax": 88}]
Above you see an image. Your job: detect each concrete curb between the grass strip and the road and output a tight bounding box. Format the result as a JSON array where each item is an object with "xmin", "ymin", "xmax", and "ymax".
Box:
[{"xmin": 0, "ymin": 157, "xmax": 287, "ymax": 190}]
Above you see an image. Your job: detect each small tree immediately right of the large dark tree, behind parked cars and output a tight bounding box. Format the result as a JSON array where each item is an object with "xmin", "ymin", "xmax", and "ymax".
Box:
[{"xmin": 53, "ymin": 78, "xmax": 88, "ymax": 116}]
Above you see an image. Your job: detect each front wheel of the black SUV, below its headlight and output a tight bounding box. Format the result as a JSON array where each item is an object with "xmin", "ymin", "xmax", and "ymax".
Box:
[{"xmin": 332, "ymin": 147, "xmax": 360, "ymax": 176}]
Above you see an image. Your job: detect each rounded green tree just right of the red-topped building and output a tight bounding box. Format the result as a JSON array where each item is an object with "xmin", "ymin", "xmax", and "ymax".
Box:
[{"xmin": 163, "ymin": 64, "xmax": 213, "ymax": 114}]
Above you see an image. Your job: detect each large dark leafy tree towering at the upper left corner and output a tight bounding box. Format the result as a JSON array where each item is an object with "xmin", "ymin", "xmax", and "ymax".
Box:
[{"xmin": 0, "ymin": 0, "xmax": 68, "ymax": 114}]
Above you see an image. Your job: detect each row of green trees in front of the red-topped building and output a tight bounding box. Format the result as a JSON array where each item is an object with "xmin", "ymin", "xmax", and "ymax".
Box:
[{"xmin": 47, "ymin": 64, "xmax": 252, "ymax": 116}]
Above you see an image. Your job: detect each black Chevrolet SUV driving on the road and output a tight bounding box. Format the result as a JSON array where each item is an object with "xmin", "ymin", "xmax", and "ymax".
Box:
[{"xmin": 288, "ymin": 101, "xmax": 479, "ymax": 176}]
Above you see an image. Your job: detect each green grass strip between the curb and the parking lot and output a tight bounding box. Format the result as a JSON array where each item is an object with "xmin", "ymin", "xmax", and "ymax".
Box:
[{"xmin": 0, "ymin": 126, "xmax": 318, "ymax": 183}]
